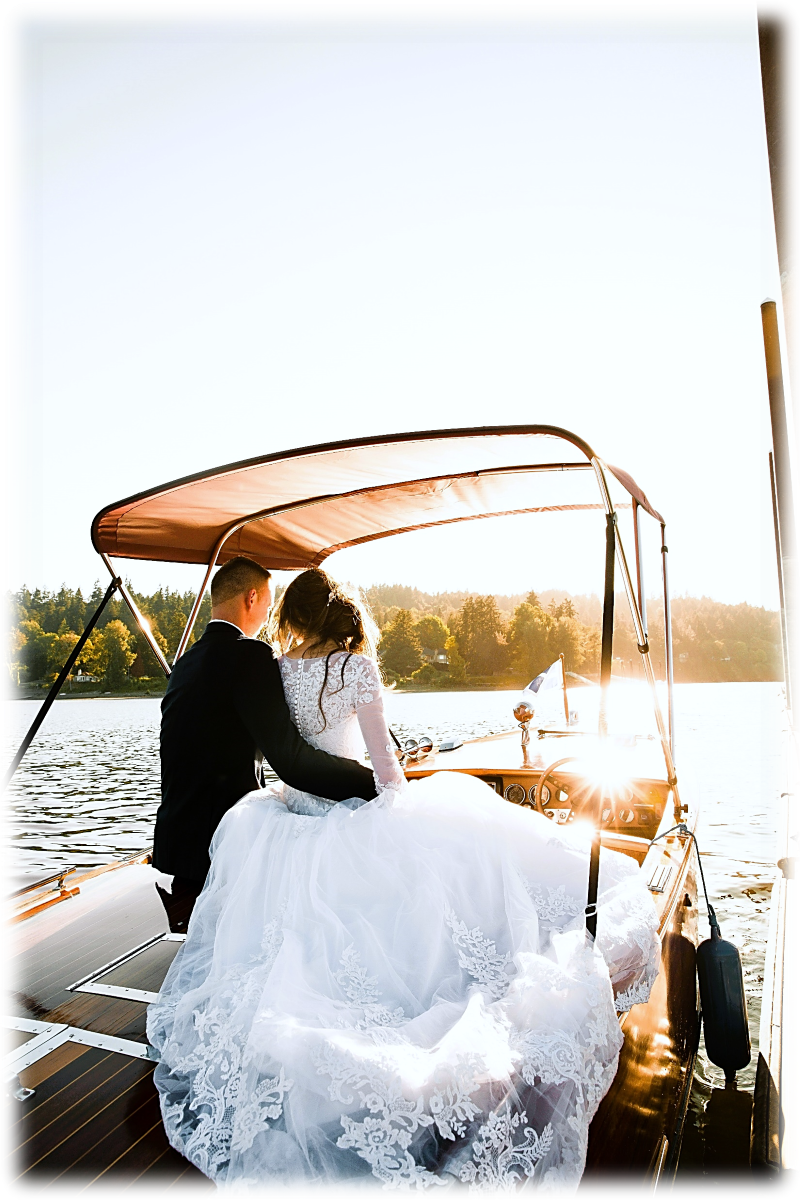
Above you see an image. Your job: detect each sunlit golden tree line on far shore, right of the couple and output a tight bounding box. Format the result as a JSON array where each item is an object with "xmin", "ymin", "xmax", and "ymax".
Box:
[{"xmin": 367, "ymin": 584, "xmax": 783, "ymax": 688}]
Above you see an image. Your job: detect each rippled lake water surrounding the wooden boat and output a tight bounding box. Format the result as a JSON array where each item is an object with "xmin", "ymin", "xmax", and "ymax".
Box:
[{"xmin": 2, "ymin": 683, "xmax": 786, "ymax": 1193}]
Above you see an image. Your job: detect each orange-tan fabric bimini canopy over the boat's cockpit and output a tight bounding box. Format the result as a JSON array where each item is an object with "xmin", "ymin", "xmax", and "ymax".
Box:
[{"xmin": 91, "ymin": 425, "xmax": 662, "ymax": 570}]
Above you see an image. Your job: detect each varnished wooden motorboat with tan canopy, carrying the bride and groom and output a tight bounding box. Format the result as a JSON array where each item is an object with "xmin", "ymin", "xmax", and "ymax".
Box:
[{"xmin": 2, "ymin": 425, "xmax": 714, "ymax": 1196}]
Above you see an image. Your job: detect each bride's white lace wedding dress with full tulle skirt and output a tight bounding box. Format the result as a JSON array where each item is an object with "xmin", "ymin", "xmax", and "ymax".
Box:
[{"xmin": 148, "ymin": 654, "xmax": 658, "ymax": 1198}]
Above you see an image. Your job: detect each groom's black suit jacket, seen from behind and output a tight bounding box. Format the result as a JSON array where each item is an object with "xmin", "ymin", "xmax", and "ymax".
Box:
[{"xmin": 158, "ymin": 622, "xmax": 375, "ymax": 883}]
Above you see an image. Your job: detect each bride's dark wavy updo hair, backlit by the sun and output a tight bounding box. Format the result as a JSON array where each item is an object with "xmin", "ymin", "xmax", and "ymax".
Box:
[{"xmin": 270, "ymin": 568, "xmax": 379, "ymax": 660}]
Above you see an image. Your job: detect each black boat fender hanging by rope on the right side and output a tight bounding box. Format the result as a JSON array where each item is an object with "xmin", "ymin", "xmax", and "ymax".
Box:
[{"xmin": 654, "ymin": 824, "xmax": 751, "ymax": 1085}]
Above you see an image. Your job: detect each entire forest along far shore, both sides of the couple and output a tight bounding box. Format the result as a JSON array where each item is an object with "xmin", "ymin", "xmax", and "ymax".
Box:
[{"xmin": 1, "ymin": 583, "xmax": 783, "ymax": 696}]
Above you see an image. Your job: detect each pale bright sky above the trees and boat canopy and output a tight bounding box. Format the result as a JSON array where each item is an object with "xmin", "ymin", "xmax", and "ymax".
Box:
[{"xmin": 1, "ymin": 2, "xmax": 796, "ymax": 608}]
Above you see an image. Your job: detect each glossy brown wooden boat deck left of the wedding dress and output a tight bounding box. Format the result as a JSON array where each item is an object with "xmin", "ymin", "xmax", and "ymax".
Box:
[{"xmin": 2, "ymin": 865, "xmax": 213, "ymax": 1196}]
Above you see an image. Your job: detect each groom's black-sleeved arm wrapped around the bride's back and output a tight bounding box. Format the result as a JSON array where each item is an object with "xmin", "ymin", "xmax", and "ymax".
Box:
[{"xmin": 230, "ymin": 638, "xmax": 377, "ymax": 800}]
